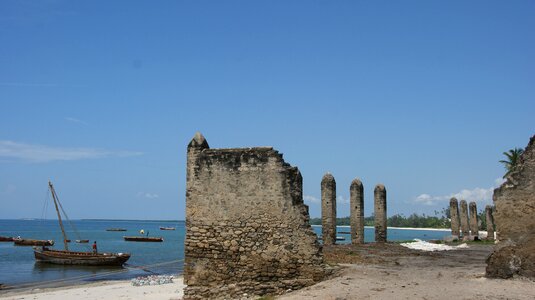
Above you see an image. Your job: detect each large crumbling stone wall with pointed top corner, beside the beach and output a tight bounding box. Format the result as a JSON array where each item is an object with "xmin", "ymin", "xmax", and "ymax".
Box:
[{"xmin": 184, "ymin": 133, "xmax": 324, "ymax": 299}]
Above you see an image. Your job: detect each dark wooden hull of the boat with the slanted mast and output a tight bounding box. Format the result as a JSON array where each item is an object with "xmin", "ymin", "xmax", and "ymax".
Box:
[{"xmin": 34, "ymin": 249, "xmax": 130, "ymax": 266}]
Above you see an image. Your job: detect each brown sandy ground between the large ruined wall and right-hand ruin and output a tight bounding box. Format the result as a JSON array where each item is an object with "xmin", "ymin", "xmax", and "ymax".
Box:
[{"xmin": 277, "ymin": 244, "xmax": 535, "ymax": 300}]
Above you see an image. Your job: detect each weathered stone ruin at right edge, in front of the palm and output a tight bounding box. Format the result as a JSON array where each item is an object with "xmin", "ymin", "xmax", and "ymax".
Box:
[{"xmin": 487, "ymin": 135, "xmax": 535, "ymax": 278}]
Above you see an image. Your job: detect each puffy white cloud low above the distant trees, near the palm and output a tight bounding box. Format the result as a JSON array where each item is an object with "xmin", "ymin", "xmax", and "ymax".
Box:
[{"xmin": 413, "ymin": 178, "xmax": 504, "ymax": 205}]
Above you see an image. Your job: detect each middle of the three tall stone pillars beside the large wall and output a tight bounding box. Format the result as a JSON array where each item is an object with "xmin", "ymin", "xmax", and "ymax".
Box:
[{"xmin": 349, "ymin": 178, "xmax": 364, "ymax": 244}]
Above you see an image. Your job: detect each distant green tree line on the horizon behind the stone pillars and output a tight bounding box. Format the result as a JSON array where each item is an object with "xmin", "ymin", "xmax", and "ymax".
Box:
[{"xmin": 310, "ymin": 208, "xmax": 486, "ymax": 230}]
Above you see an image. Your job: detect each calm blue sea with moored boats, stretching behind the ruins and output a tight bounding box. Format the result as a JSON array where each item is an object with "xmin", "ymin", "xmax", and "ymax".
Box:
[{"xmin": 0, "ymin": 220, "xmax": 450, "ymax": 287}]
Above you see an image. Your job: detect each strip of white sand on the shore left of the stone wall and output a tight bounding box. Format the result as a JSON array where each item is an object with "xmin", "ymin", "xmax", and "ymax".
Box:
[{"xmin": 0, "ymin": 277, "xmax": 184, "ymax": 300}]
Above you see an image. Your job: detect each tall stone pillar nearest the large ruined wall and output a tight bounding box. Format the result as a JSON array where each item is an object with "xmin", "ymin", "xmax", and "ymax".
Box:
[{"xmin": 321, "ymin": 173, "xmax": 336, "ymax": 245}]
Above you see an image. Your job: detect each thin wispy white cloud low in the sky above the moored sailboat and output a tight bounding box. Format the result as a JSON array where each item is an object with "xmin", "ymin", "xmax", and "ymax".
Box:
[{"xmin": 0, "ymin": 140, "xmax": 143, "ymax": 163}]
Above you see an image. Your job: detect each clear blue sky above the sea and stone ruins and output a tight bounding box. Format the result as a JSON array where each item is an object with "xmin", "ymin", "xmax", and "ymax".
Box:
[{"xmin": 0, "ymin": 1, "xmax": 535, "ymax": 219}]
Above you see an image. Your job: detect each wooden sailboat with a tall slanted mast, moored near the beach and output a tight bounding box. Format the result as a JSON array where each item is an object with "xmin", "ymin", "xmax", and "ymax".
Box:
[{"xmin": 33, "ymin": 181, "xmax": 130, "ymax": 266}]
